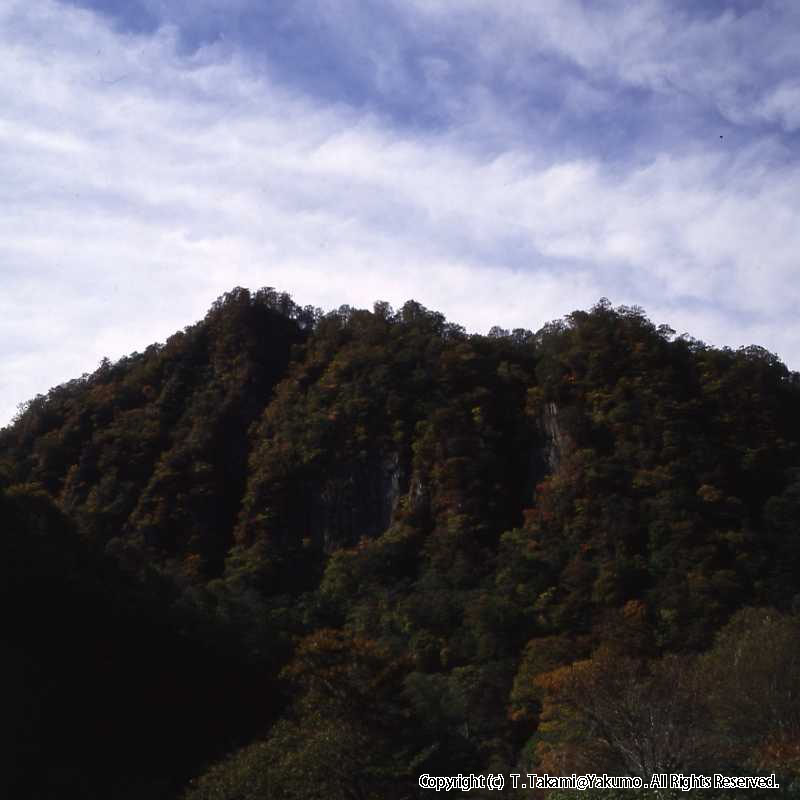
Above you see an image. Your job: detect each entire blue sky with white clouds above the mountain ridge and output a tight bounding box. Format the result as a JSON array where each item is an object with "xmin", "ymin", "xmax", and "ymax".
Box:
[{"xmin": 0, "ymin": 0, "xmax": 800, "ymax": 425}]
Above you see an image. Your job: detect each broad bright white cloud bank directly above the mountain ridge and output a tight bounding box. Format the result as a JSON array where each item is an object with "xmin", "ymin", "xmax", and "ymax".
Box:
[{"xmin": 0, "ymin": 0, "xmax": 800, "ymax": 428}]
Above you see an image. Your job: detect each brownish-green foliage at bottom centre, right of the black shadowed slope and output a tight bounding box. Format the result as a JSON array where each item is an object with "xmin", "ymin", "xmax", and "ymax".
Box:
[{"xmin": 186, "ymin": 629, "xmax": 435, "ymax": 800}]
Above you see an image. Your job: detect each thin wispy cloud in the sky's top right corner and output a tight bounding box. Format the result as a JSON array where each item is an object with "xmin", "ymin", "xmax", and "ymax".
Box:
[{"xmin": 403, "ymin": 0, "xmax": 800, "ymax": 131}]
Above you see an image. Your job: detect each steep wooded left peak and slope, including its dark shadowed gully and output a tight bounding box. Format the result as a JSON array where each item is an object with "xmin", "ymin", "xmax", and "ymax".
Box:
[{"xmin": 0, "ymin": 289, "xmax": 314, "ymax": 577}]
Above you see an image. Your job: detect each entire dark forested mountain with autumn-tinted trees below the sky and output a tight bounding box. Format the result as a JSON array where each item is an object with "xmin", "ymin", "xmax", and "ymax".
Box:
[{"xmin": 0, "ymin": 288, "xmax": 800, "ymax": 800}]
